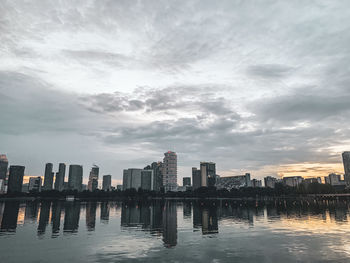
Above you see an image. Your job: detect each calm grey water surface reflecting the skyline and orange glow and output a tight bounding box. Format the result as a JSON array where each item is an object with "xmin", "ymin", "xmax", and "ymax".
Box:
[{"xmin": 0, "ymin": 201, "xmax": 350, "ymax": 262}]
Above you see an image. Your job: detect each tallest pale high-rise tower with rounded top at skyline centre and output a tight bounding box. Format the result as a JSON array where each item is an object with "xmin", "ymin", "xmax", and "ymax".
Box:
[{"xmin": 163, "ymin": 151, "xmax": 177, "ymax": 192}]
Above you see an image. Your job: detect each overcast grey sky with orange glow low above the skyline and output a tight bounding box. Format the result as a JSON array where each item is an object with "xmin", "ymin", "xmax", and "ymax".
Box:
[{"xmin": 0, "ymin": 0, "xmax": 350, "ymax": 186}]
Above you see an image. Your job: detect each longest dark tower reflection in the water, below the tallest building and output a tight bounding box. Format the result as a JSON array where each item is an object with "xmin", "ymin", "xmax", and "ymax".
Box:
[{"xmin": 163, "ymin": 202, "xmax": 177, "ymax": 247}]
